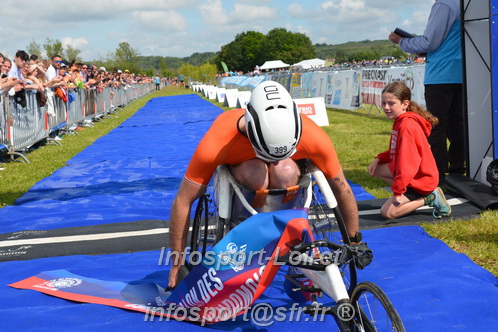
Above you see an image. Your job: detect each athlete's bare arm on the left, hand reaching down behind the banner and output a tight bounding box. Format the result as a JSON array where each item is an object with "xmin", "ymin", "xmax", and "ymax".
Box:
[{"xmin": 168, "ymin": 178, "xmax": 206, "ymax": 287}]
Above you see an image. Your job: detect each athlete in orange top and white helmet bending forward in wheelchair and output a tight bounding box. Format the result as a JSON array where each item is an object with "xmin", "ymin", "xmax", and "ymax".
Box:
[{"xmin": 169, "ymin": 81, "xmax": 369, "ymax": 288}]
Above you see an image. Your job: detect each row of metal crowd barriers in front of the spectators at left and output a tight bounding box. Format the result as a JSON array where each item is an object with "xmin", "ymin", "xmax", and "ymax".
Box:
[{"xmin": 0, "ymin": 84, "xmax": 155, "ymax": 162}]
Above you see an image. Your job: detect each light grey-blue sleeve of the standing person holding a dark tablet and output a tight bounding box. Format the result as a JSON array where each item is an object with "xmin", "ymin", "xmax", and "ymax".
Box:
[{"xmin": 399, "ymin": 1, "xmax": 459, "ymax": 53}]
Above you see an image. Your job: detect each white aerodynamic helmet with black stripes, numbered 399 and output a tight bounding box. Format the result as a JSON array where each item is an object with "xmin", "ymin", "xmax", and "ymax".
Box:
[{"xmin": 245, "ymin": 81, "xmax": 301, "ymax": 161}]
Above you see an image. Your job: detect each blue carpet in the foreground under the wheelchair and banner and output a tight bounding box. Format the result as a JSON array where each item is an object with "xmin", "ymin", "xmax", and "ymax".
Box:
[{"xmin": 0, "ymin": 226, "xmax": 498, "ymax": 331}]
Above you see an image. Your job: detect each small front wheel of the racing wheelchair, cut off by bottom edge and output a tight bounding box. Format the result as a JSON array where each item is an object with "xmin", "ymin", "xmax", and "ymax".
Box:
[{"xmin": 351, "ymin": 281, "xmax": 406, "ymax": 332}]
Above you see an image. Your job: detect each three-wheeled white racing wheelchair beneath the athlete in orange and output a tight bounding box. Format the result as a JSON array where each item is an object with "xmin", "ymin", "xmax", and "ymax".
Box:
[{"xmin": 187, "ymin": 161, "xmax": 405, "ymax": 331}]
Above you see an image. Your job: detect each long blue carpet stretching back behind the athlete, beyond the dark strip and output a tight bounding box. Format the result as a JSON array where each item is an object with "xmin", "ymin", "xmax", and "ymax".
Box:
[{"xmin": 0, "ymin": 94, "xmax": 373, "ymax": 233}]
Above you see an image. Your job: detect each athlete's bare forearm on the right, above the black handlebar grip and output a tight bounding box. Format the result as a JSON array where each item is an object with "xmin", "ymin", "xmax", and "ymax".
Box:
[{"xmin": 327, "ymin": 169, "xmax": 360, "ymax": 237}]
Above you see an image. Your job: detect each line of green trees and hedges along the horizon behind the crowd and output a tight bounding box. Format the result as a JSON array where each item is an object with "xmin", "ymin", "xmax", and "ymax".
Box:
[{"xmin": 26, "ymin": 28, "xmax": 407, "ymax": 80}]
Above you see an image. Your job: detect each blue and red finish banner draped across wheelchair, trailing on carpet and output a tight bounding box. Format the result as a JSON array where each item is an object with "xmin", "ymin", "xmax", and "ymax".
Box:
[{"xmin": 10, "ymin": 210, "xmax": 312, "ymax": 323}]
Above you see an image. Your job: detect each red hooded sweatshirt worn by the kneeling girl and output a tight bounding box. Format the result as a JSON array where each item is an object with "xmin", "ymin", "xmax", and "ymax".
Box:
[{"xmin": 377, "ymin": 112, "xmax": 439, "ymax": 196}]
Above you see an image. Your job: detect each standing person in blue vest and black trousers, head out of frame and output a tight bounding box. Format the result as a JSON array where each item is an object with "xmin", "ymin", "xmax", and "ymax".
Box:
[{"xmin": 389, "ymin": 0, "xmax": 467, "ymax": 183}]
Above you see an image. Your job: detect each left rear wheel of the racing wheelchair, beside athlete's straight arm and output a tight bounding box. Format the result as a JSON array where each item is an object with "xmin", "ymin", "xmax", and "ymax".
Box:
[{"xmin": 187, "ymin": 187, "xmax": 225, "ymax": 270}]
